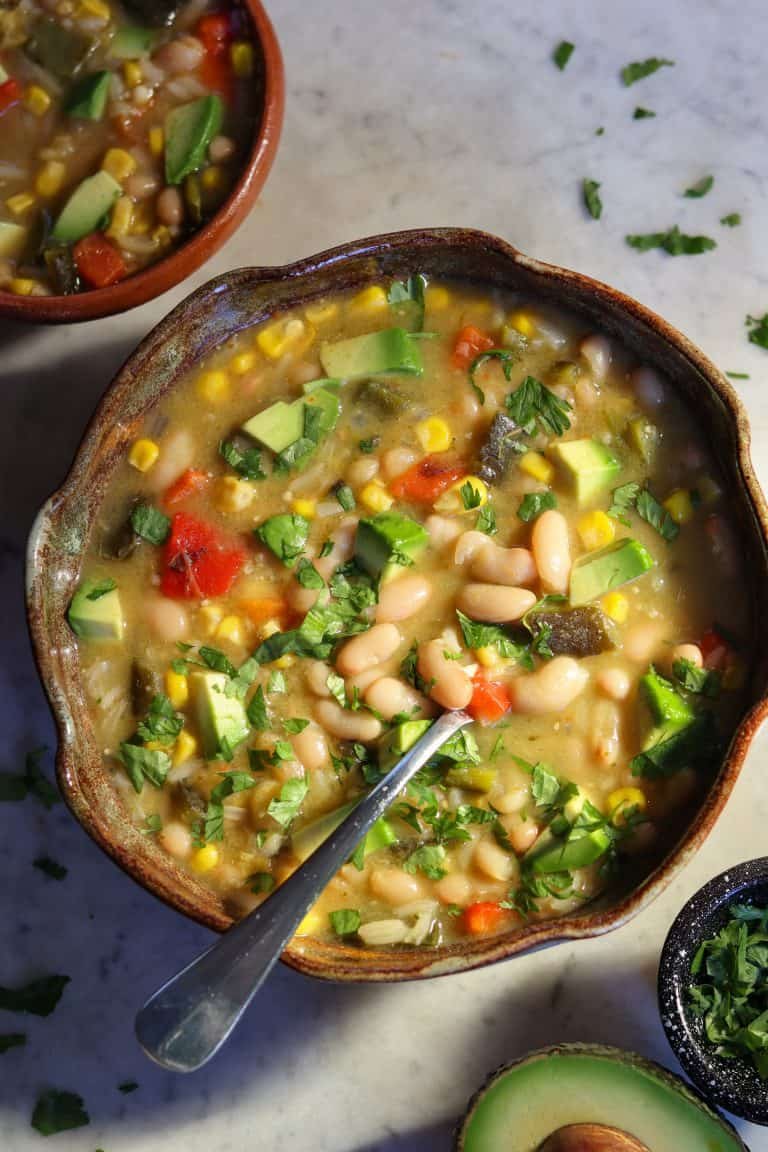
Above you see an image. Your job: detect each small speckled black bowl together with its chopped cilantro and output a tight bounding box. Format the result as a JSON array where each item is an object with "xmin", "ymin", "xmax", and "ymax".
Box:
[{"xmin": 659, "ymin": 857, "xmax": 768, "ymax": 1126}]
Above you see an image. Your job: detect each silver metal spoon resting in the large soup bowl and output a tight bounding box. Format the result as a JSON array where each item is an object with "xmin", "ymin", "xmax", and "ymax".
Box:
[{"xmin": 136, "ymin": 712, "xmax": 471, "ymax": 1073}]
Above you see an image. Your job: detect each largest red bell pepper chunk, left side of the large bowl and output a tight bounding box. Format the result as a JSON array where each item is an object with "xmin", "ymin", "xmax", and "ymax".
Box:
[{"xmin": 160, "ymin": 511, "xmax": 245, "ymax": 600}]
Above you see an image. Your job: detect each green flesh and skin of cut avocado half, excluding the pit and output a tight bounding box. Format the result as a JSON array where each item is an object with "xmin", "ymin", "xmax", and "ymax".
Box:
[{"xmin": 455, "ymin": 1044, "xmax": 748, "ymax": 1152}]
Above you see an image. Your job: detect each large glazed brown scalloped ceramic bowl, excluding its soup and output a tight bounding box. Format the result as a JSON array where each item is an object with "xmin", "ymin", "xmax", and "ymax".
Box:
[{"xmin": 28, "ymin": 228, "xmax": 768, "ymax": 980}]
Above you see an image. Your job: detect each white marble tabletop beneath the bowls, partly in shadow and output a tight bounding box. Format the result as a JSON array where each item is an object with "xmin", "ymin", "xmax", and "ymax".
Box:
[{"xmin": 0, "ymin": 0, "xmax": 768, "ymax": 1152}]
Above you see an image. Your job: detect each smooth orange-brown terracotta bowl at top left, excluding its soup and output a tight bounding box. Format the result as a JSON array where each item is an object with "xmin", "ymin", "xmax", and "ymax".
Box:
[{"xmin": 0, "ymin": 0, "xmax": 286, "ymax": 324}]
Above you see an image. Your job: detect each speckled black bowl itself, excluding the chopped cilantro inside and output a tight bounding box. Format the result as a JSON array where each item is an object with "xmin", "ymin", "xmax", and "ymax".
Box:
[{"xmin": 659, "ymin": 856, "xmax": 768, "ymax": 1124}]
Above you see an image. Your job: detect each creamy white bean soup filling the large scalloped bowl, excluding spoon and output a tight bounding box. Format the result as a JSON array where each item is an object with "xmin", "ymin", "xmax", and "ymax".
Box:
[{"xmin": 70, "ymin": 280, "xmax": 748, "ymax": 947}]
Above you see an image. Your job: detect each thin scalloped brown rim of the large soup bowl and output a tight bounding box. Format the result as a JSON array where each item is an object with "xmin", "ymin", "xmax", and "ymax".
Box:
[{"xmin": 26, "ymin": 228, "xmax": 768, "ymax": 982}]
